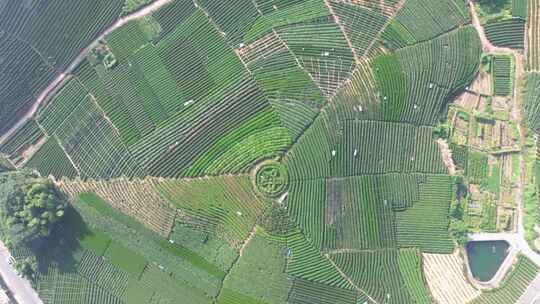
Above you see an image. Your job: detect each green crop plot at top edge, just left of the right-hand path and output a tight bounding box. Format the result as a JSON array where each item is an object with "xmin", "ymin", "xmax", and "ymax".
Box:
[{"xmin": 382, "ymin": 0, "xmax": 471, "ymax": 49}]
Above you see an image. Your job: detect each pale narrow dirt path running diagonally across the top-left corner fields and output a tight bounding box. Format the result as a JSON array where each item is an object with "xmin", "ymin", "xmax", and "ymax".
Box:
[{"xmin": 0, "ymin": 0, "xmax": 173, "ymax": 145}]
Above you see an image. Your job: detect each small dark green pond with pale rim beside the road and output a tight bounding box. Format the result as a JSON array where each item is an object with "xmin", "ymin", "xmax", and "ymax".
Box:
[{"xmin": 465, "ymin": 241, "xmax": 510, "ymax": 282}]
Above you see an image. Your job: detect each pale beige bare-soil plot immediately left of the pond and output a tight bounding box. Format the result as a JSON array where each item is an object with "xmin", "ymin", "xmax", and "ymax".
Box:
[{"xmin": 422, "ymin": 251, "xmax": 480, "ymax": 304}]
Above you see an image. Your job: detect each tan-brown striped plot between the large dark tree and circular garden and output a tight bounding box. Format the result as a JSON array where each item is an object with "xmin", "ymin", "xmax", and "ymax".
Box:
[{"xmin": 61, "ymin": 179, "xmax": 175, "ymax": 237}]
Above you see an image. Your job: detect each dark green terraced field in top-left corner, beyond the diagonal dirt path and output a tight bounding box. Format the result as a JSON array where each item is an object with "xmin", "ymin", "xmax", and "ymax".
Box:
[{"xmin": 0, "ymin": 0, "xmax": 123, "ymax": 132}]
